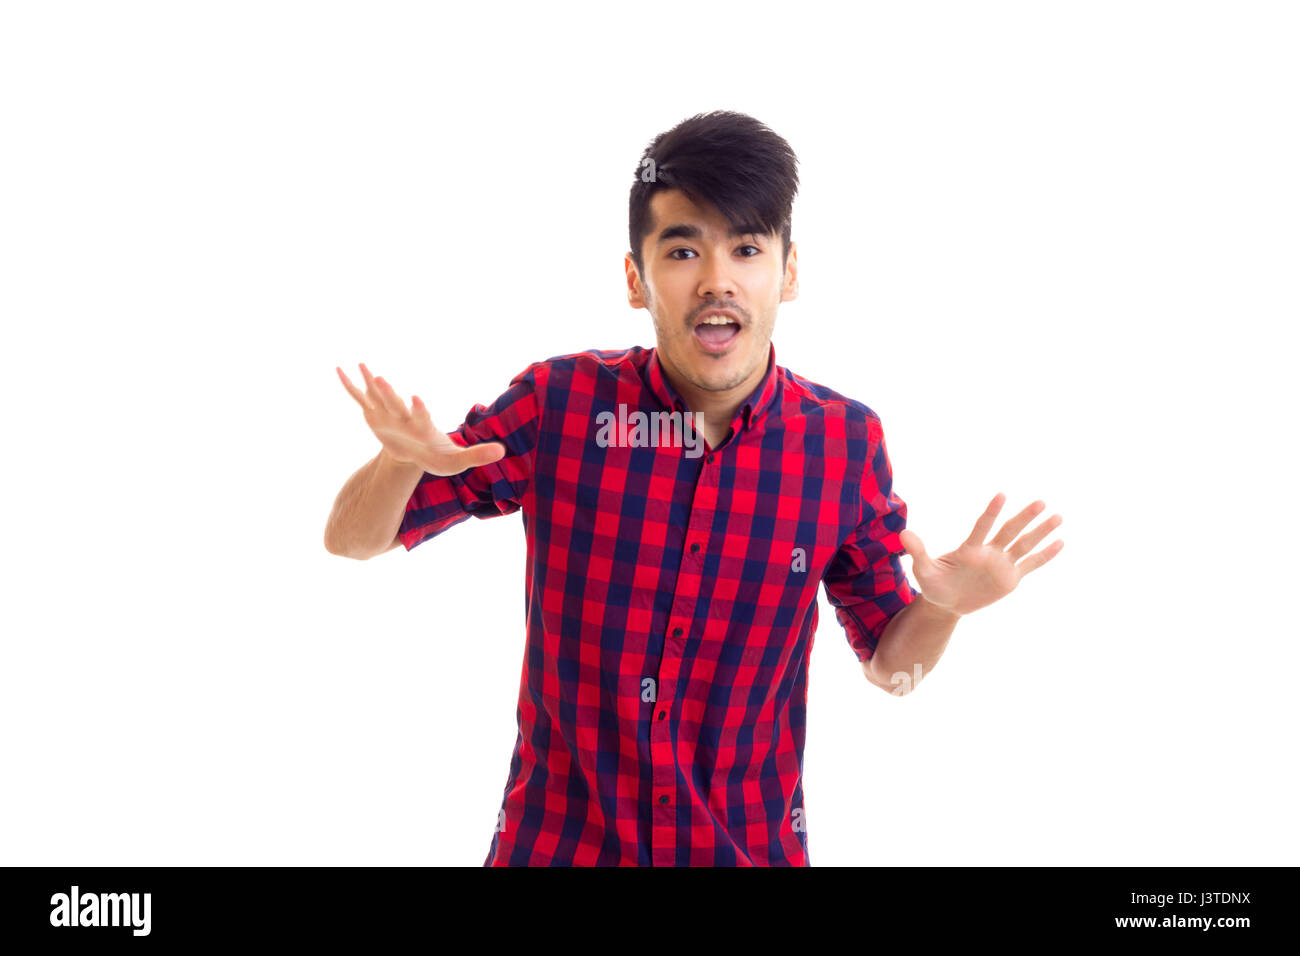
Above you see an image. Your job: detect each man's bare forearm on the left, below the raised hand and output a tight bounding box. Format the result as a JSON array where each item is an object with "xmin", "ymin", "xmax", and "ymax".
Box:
[{"xmin": 325, "ymin": 449, "xmax": 424, "ymax": 561}]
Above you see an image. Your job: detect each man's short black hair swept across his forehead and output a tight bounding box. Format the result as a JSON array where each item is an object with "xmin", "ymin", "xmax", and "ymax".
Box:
[{"xmin": 628, "ymin": 109, "xmax": 800, "ymax": 278}]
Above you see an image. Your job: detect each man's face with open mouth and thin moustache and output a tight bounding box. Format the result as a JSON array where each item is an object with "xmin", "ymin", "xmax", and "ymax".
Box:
[{"xmin": 624, "ymin": 190, "xmax": 798, "ymax": 399}]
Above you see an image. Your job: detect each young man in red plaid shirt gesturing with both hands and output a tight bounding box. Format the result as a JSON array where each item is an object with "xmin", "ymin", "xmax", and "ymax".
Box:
[{"xmin": 325, "ymin": 112, "xmax": 1062, "ymax": 866}]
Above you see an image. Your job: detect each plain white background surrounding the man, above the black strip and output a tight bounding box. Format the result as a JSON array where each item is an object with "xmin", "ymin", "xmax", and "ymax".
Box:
[{"xmin": 0, "ymin": 0, "xmax": 1300, "ymax": 866}]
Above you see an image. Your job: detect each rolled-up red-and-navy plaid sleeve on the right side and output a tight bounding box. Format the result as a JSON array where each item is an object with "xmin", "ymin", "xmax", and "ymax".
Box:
[{"xmin": 822, "ymin": 416, "xmax": 917, "ymax": 661}]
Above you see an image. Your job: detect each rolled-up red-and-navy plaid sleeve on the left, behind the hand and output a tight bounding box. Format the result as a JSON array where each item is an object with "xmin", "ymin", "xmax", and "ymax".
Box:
[{"xmin": 398, "ymin": 362, "xmax": 545, "ymax": 551}]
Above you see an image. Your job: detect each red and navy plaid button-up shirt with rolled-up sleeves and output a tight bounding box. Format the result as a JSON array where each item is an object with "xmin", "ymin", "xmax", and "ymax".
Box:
[{"xmin": 398, "ymin": 346, "xmax": 917, "ymax": 866}]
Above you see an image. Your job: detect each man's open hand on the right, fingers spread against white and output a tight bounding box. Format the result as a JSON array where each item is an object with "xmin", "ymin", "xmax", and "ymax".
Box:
[{"xmin": 901, "ymin": 494, "xmax": 1065, "ymax": 614}]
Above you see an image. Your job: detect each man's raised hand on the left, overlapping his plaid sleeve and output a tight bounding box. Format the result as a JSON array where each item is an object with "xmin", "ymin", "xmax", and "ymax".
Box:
[{"xmin": 334, "ymin": 362, "xmax": 506, "ymax": 476}]
